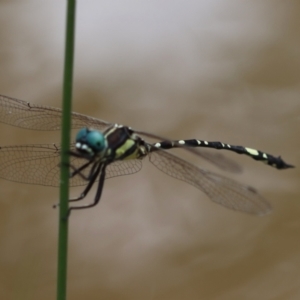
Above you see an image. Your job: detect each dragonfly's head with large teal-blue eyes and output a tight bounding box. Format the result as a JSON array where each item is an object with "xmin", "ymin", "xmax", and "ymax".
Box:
[{"xmin": 76, "ymin": 128, "xmax": 107, "ymax": 156}]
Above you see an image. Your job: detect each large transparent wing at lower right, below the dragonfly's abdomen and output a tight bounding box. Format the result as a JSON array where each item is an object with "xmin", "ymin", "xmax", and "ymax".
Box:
[{"xmin": 149, "ymin": 150, "xmax": 271, "ymax": 215}]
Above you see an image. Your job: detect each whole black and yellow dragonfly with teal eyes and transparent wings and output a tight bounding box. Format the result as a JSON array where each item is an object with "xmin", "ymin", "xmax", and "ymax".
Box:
[{"xmin": 0, "ymin": 95, "xmax": 294, "ymax": 215}]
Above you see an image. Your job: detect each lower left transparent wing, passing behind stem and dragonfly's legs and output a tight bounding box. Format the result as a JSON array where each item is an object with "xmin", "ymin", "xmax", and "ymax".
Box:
[{"xmin": 0, "ymin": 144, "xmax": 142, "ymax": 186}]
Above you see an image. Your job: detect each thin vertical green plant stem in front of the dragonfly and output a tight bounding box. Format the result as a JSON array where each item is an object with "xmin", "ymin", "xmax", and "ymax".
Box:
[{"xmin": 57, "ymin": 0, "xmax": 76, "ymax": 300}]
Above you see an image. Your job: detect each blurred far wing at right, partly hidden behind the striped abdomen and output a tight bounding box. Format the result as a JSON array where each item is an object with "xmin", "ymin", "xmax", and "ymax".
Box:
[{"xmin": 135, "ymin": 131, "xmax": 242, "ymax": 173}]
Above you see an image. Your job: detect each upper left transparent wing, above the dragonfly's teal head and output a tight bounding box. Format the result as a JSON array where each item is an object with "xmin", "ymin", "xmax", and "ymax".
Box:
[{"xmin": 0, "ymin": 95, "xmax": 111, "ymax": 130}]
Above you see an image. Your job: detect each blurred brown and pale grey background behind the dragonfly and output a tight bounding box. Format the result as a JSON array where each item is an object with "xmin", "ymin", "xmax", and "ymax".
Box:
[{"xmin": 0, "ymin": 0, "xmax": 300, "ymax": 300}]
